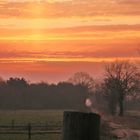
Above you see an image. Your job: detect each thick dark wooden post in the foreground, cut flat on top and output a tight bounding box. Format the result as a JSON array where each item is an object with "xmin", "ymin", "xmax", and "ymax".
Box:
[{"xmin": 63, "ymin": 112, "xmax": 100, "ymax": 140}]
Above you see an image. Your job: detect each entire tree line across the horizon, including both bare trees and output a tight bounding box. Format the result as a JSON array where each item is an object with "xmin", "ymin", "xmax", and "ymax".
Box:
[{"xmin": 0, "ymin": 61, "xmax": 140, "ymax": 116}]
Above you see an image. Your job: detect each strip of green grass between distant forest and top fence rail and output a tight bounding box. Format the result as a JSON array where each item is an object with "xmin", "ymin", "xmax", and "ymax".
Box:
[{"xmin": 0, "ymin": 110, "xmax": 63, "ymax": 125}]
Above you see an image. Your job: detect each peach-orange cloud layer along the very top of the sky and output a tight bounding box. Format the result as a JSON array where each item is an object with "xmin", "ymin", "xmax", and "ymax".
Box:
[{"xmin": 0, "ymin": 0, "xmax": 140, "ymax": 18}]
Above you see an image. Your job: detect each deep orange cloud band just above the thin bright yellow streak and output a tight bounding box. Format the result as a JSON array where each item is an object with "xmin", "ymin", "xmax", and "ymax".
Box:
[{"xmin": 0, "ymin": 38, "xmax": 140, "ymax": 59}]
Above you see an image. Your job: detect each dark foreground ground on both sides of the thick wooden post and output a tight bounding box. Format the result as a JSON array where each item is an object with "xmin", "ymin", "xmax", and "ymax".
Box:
[{"xmin": 0, "ymin": 110, "xmax": 140, "ymax": 140}]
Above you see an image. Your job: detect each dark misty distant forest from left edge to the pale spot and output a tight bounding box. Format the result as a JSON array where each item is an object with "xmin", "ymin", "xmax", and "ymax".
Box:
[{"xmin": 0, "ymin": 78, "xmax": 87, "ymax": 110}]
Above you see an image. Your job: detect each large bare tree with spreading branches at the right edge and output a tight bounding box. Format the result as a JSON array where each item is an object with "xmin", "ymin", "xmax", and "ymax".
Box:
[{"xmin": 105, "ymin": 61, "xmax": 140, "ymax": 116}]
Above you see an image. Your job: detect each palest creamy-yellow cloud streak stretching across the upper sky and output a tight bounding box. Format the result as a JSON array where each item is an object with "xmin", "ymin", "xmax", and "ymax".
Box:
[{"xmin": 0, "ymin": 16, "xmax": 140, "ymax": 30}]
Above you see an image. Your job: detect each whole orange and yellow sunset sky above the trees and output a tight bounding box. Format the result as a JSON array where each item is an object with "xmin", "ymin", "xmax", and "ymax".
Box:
[{"xmin": 0, "ymin": 0, "xmax": 140, "ymax": 82}]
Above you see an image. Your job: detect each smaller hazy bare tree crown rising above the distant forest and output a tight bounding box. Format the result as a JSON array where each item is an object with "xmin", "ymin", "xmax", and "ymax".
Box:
[{"xmin": 68, "ymin": 72, "xmax": 95, "ymax": 92}]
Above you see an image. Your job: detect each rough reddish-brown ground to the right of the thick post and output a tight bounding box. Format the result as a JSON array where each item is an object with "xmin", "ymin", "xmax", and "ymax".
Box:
[{"xmin": 101, "ymin": 110, "xmax": 140, "ymax": 140}]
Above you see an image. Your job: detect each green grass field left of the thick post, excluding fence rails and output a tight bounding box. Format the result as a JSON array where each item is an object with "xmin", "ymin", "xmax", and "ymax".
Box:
[{"xmin": 0, "ymin": 110, "xmax": 63, "ymax": 140}]
